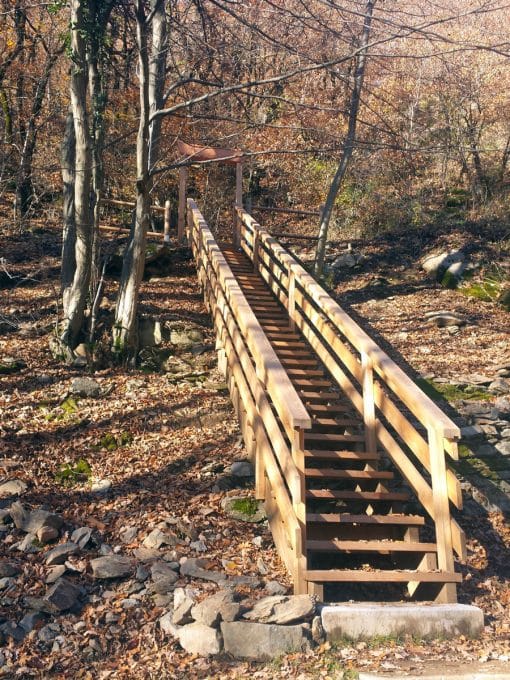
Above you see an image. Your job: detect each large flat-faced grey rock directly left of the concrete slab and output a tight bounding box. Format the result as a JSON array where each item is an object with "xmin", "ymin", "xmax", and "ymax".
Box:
[{"xmin": 221, "ymin": 621, "xmax": 309, "ymax": 661}]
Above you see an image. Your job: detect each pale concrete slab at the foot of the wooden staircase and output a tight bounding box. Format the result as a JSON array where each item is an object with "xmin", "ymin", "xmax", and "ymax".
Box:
[{"xmin": 321, "ymin": 603, "xmax": 483, "ymax": 642}]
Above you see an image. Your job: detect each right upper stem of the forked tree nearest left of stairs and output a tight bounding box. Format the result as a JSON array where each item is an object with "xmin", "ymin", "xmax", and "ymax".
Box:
[{"xmin": 148, "ymin": 0, "xmax": 168, "ymax": 172}]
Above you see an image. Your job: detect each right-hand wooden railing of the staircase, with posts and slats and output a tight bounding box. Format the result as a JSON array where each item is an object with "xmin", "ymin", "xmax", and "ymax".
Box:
[{"xmin": 234, "ymin": 208, "xmax": 466, "ymax": 584}]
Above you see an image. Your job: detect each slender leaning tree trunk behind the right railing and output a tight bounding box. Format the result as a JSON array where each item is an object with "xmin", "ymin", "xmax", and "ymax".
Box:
[{"xmin": 314, "ymin": 0, "xmax": 376, "ymax": 277}]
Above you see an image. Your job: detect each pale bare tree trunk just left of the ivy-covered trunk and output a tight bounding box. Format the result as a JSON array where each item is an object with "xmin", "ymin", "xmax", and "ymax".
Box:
[{"xmin": 61, "ymin": 0, "xmax": 92, "ymax": 350}]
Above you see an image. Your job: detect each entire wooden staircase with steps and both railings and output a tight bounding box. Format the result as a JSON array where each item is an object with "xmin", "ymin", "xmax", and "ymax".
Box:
[{"xmin": 187, "ymin": 200, "xmax": 465, "ymax": 602}]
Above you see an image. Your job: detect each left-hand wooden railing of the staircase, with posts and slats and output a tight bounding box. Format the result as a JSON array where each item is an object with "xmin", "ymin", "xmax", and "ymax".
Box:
[{"xmin": 187, "ymin": 199, "xmax": 311, "ymax": 592}]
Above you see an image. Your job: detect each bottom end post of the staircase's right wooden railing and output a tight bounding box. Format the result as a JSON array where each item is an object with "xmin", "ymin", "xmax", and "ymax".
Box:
[{"xmin": 427, "ymin": 427, "xmax": 457, "ymax": 602}]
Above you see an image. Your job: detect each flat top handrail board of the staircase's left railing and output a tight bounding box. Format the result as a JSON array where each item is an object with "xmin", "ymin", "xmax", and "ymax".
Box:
[{"xmin": 188, "ymin": 199, "xmax": 312, "ymax": 431}]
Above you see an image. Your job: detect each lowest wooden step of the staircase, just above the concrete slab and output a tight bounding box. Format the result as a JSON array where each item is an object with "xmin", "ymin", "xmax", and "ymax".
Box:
[{"xmin": 304, "ymin": 569, "xmax": 462, "ymax": 583}]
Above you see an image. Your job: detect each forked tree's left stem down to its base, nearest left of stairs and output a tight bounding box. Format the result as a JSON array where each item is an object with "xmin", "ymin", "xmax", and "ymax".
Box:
[{"xmin": 113, "ymin": 0, "xmax": 151, "ymax": 362}]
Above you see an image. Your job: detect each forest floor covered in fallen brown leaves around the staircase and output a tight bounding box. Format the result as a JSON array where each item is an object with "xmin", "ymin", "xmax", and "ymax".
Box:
[{"xmin": 0, "ymin": 219, "xmax": 510, "ymax": 680}]
